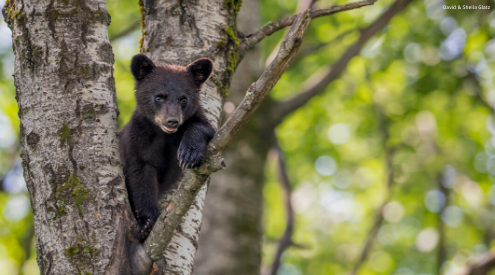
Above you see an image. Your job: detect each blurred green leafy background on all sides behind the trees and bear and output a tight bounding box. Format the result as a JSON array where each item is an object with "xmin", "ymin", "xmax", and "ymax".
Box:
[{"xmin": 0, "ymin": 0, "xmax": 495, "ymax": 275}]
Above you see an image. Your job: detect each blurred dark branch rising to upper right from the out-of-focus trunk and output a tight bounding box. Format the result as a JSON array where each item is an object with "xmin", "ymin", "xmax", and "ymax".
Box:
[{"xmin": 272, "ymin": 0, "xmax": 413, "ymax": 124}]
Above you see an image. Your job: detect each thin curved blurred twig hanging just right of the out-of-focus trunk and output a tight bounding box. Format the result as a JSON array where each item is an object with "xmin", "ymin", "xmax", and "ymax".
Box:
[{"xmin": 269, "ymin": 144, "xmax": 294, "ymax": 275}]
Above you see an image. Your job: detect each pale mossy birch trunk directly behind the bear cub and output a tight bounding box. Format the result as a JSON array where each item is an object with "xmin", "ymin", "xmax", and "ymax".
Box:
[{"xmin": 140, "ymin": 0, "xmax": 242, "ymax": 274}]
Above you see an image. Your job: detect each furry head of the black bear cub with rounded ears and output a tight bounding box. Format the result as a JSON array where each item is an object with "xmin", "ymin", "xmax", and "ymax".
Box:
[{"xmin": 131, "ymin": 54, "xmax": 213, "ymax": 134}]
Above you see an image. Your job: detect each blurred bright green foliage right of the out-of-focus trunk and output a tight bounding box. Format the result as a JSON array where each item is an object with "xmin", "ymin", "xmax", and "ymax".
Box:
[{"xmin": 261, "ymin": 0, "xmax": 495, "ymax": 274}]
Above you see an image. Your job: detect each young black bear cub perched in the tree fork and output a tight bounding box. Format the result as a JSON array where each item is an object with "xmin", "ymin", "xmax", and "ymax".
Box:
[{"xmin": 119, "ymin": 54, "xmax": 215, "ymax": 241}]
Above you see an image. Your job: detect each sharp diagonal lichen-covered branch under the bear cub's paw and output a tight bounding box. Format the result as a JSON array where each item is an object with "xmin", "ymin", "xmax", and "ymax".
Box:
[{"xmin": 144, "ymin": 11, "xmax": 310, "ymax": 261}]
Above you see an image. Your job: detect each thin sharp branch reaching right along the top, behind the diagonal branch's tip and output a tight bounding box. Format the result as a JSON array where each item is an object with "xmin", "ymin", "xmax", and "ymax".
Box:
[{"xmin": 244, "ymin": 0, "xmax": 377, "ymax": 49}]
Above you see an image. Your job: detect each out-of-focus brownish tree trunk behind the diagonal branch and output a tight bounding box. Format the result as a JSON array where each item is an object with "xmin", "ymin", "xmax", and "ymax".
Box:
[{"xmin": 194, "ymin": 1, "xmax": 273, "ymax": 275}]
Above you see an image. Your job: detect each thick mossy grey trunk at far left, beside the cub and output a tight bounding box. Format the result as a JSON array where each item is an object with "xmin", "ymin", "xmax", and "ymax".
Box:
[{"xmin": 3, "ymin": 0, "xmax": 138, "ymax": 274}]
